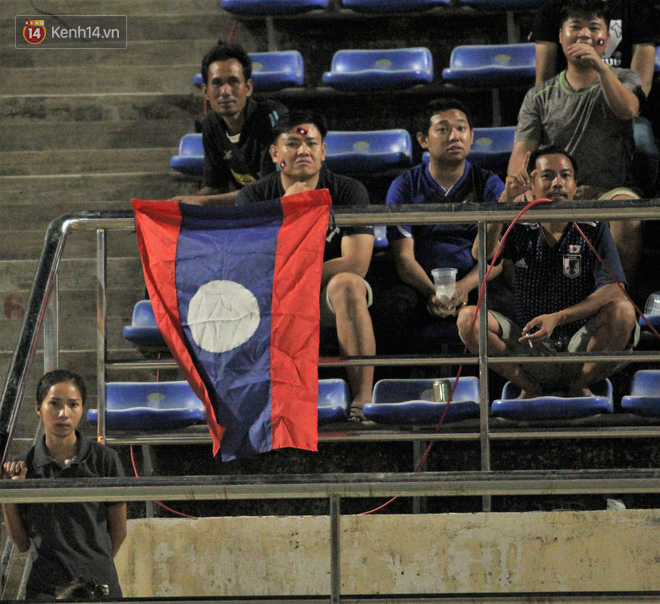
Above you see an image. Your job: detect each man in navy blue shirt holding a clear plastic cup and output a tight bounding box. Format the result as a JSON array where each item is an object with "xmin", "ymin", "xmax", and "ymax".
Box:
[{"xmin": 379, "ymin": 99, "xmax": 504, "ymax": 350}]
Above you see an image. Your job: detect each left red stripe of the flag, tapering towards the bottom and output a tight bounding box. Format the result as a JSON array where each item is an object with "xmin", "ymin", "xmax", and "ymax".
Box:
[{"xmin": 131, "ymin": 199, "xmax": 224, "ymax": 455}]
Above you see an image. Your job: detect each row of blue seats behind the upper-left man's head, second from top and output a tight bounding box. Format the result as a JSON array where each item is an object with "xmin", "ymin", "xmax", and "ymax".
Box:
[{"xmin": 193, "ymin": 43, "xmax": 536, "ymax": 92}]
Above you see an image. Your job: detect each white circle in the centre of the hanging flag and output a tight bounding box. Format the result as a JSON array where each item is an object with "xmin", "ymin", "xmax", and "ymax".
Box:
[{"xmin": 188, "ymin": 281, "xmax": 261, "ymax": 352}]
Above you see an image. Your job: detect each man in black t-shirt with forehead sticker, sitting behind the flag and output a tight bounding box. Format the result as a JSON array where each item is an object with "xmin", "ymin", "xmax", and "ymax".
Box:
[{"xmin": 236, "ymin": 111, "xmax": 376, "ymax": 421}]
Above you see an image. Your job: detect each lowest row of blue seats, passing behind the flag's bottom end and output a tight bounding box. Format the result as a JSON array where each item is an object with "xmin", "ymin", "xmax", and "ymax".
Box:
[{"xmin": 87, "ymin": 370, "xmax": 660, "ymax": 430}]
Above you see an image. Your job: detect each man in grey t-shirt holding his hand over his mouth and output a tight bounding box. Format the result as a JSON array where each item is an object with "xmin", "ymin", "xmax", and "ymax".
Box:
[{"xmin": 508, "ymin": 0, "xmax": 646, "ymax": 288}]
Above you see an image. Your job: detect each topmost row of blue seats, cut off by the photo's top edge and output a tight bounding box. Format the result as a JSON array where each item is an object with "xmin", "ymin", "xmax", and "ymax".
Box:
[{"xmin": 220, "ymin": 0, "xmax": 544, "ymax": 16}]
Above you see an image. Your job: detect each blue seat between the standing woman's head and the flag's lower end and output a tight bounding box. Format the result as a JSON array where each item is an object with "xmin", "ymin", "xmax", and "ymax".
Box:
[{"xmin": 87, "ymin": 381, "xmax": 206, "ymax": 430}]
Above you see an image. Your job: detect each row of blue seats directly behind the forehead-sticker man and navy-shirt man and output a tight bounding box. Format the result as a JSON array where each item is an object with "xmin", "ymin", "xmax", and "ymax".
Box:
[{"xmin": 170, "ymin": 126, "xmax": 516, "ymax": 176}]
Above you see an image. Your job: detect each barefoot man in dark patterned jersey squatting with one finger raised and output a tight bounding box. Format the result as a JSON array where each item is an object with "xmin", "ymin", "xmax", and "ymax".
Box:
[{"xmin": 457, "ymin": 147, "xmax": 639, "ymax": 398}]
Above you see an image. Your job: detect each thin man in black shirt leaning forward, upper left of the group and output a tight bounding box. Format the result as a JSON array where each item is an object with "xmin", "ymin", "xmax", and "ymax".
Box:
[{"xmin": 175, "ymin": 44, "xmax": 287, "ymax": 205}]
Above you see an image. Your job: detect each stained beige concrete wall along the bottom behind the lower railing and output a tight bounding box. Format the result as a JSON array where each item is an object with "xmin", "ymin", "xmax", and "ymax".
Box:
[{"xmin": 117, "ymin": 510, "xmax": 660, "ymax": 597}]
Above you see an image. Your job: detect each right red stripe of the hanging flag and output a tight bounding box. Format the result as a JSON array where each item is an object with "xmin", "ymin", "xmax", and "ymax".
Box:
[{"xmin": 270, "ymin": 189, "xmax": 332, "ymax": 451}]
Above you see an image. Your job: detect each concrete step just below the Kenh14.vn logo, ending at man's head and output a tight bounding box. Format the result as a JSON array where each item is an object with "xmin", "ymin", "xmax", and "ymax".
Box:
[{"xmin": 0, "ymin": 63, "xmax": 199, "ymax": 95}]
